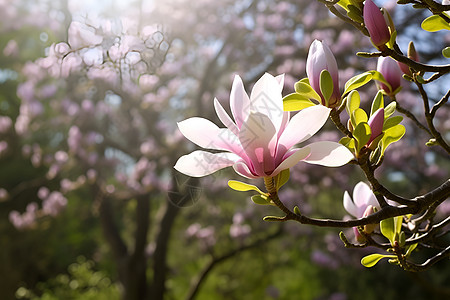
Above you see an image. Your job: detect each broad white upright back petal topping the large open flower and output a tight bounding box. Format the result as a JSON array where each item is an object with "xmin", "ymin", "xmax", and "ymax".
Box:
[{"xmin": 250, "ymin": 73, "xmax": 284, "ymax": 132}]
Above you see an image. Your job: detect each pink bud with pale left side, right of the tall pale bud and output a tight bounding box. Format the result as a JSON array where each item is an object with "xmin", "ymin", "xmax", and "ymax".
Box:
[{"xmin": 377, "ymin": 57, "xmax": 403, "ymax": 97}]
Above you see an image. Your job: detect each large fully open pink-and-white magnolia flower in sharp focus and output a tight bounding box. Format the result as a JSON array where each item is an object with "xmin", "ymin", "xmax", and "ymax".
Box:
[{"xmin": 175, "ymin": 73, "xmax": 353, "ymax": 178}]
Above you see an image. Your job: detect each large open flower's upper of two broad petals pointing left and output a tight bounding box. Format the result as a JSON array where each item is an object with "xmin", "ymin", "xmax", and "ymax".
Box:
[{"xmin": 178, "ymin": 117, "xmax": 241, "ymax": 152}]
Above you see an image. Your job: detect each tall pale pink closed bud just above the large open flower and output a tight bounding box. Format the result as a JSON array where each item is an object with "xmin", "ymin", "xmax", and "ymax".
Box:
[{"xmin": 306, "ymin": 40, "xmax": 341, "ymax": 107}]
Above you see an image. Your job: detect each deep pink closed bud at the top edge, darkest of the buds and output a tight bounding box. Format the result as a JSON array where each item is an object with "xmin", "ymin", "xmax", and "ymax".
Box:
[{"xmin": 363, "ymin": 0, "xmax": 391, "ymax": 48}]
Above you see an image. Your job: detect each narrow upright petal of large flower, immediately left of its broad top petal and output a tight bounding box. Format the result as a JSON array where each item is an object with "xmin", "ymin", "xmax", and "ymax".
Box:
[{"xmin": 230, "ymin": 75, "xmax": 250, "ymax": 128}]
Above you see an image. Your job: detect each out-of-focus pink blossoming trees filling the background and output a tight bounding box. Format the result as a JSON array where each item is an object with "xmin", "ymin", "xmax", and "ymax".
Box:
[{"xmin": 0, "ymin": 0, "xmax": 450, "ymax": 299}]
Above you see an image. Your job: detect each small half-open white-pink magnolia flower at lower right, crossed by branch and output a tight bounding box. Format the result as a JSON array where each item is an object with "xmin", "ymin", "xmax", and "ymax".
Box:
[{"xmin": 344, "ymin": 181, "xmax": 380, "ymax": 242}]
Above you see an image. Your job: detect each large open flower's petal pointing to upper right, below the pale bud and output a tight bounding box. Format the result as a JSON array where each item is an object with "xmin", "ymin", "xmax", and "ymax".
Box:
[{"xmin": 278, "ymin": 105, "xmax": 330, "ymax": 150}]
